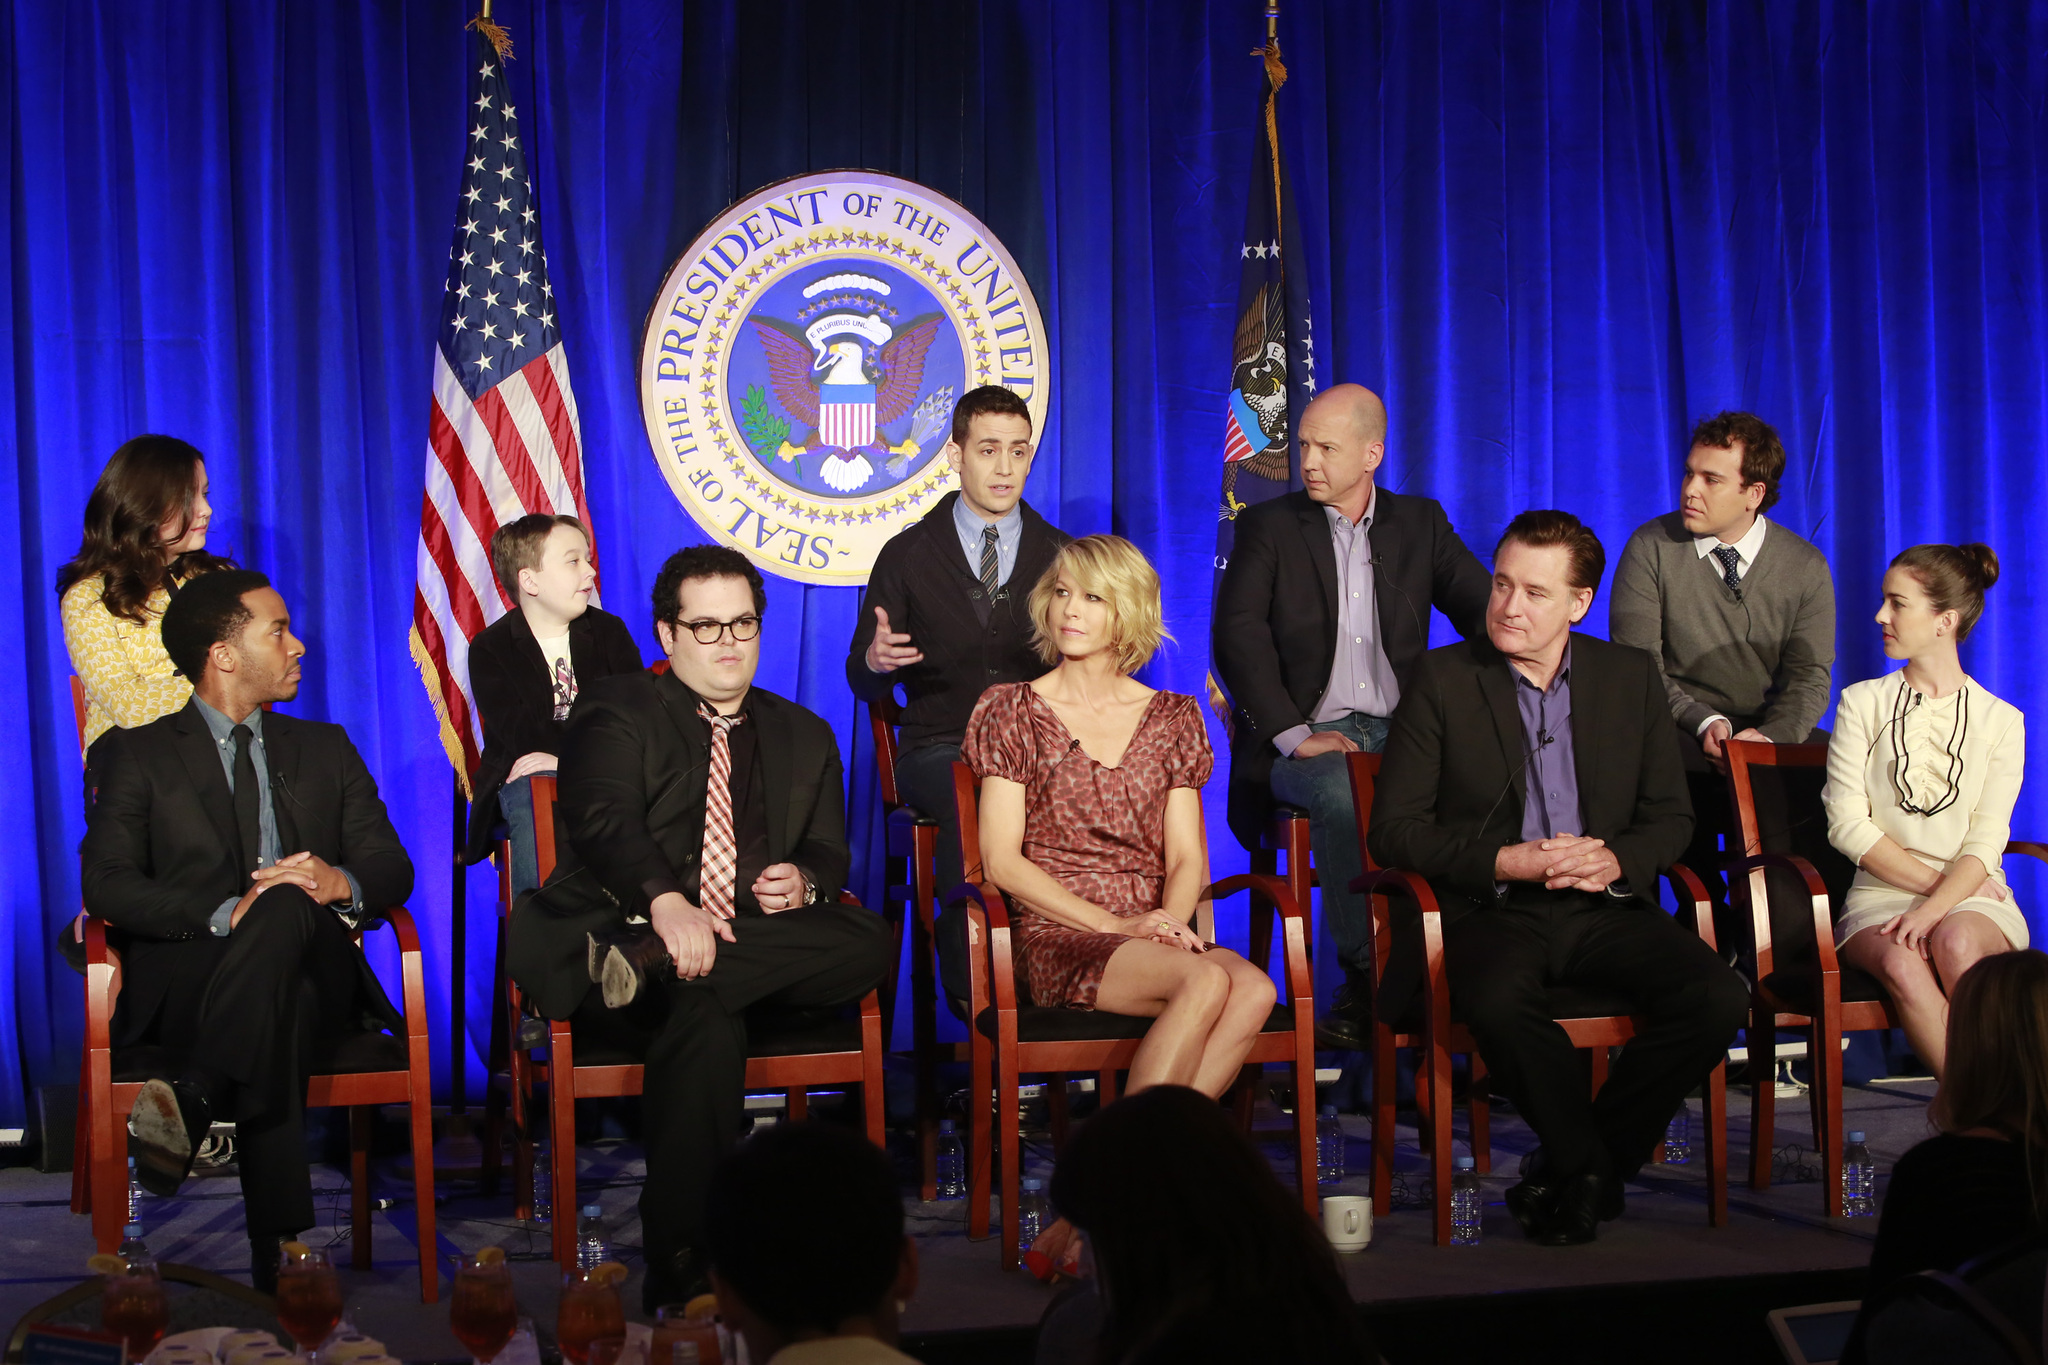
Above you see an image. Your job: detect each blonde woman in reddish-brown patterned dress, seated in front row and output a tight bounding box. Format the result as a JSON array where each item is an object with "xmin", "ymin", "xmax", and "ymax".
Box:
[{"xmin": 961, "ymin": 536, "xmax": 1274, "ymax": 1097}]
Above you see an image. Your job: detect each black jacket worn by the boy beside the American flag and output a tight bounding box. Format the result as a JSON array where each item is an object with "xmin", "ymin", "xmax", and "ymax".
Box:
[{"xmin": 463, "ymin": 608, "xmax": 641, "ymax": 864}]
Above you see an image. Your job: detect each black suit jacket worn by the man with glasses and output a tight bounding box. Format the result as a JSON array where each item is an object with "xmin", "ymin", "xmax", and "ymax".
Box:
[{"xmin": 506, "ymin": 671, "xmax": 852, "ymax": 1019}]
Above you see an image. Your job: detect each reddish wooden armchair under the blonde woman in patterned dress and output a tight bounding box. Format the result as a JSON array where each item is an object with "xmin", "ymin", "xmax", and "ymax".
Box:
[{"xmin": 950, "ymin": 763, "xmax": 1317, "ymax": 1271}]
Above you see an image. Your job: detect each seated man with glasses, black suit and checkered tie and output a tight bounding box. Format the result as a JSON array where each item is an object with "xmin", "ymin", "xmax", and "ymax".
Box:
[{"xmin": 508, "ymin": 544, "xmax": 893, "ymax": 1312}]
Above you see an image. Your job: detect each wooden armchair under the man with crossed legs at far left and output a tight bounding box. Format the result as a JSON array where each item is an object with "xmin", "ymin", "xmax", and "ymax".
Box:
[{"xmin": 72, "ymin": 907, "xmax": 440, "ymax": 1304}]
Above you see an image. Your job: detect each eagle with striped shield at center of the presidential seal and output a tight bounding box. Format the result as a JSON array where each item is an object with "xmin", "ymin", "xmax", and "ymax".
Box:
[{"xmin": 748, "ymin": 274, "xmax": 952, "ymax": 493}]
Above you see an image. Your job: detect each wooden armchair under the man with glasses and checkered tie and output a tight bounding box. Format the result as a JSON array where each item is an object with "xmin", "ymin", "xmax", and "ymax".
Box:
[{"xmin": 508, "ymin": 776, "xmax": 885, "ymax": 1271}]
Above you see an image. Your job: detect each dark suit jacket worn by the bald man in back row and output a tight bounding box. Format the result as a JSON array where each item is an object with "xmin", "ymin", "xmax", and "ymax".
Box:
[{"xmin": 1210, "ymin": 480, "xmax": 1493, "ymax": 849}]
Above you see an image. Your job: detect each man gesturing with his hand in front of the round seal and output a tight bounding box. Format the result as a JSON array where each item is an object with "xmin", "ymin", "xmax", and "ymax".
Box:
[{"xmin": 846, "ymin": 385, "xmax": 1067, "ymax": 1015}]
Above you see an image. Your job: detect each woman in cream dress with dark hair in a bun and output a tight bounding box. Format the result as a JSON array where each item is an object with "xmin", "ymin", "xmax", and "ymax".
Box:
[{"xmin": 1823, "ymin": 544, "xmax": 2028, "ymax": 1076}]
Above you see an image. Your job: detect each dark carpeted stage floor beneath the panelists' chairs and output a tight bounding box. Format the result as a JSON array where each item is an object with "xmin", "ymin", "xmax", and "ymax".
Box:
[{"xmin": 0, "ymin": 1081, "xmax": 1933, "ymax": 1365}]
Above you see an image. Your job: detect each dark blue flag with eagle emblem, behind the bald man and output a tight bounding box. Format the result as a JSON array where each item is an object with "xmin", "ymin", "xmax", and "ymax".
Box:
[{"xmin": 1208, "ymin": 39, "xmax": 1315, "ymax": 729}]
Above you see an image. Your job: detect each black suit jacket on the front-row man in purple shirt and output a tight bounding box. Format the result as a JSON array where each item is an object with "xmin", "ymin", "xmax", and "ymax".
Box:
[{"xmin": 1368, "ymin": 632, "xmax": 1692, "ymax": 1021}]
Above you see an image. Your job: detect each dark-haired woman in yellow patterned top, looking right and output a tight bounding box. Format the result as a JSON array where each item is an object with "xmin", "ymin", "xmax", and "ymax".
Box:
[{"xmin": 57, "ymin": 436, "xmax": 227, "ymax": 747}]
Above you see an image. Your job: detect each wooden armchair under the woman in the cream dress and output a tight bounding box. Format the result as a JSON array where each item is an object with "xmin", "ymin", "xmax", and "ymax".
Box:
[{"xmin": 1726, "ymin": 739, "xmax": 2048, "ymax": 1218}]
